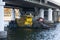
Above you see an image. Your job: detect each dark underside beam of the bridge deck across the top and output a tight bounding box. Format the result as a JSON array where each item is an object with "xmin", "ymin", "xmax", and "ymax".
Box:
[{"xmin": 3, "ymin": 0, "xmax": 57, "ymax": 8}]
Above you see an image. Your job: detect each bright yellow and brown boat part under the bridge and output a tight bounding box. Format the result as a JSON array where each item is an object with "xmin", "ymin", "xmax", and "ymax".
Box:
[{"xmin": 16, "ymin": 15, "xmax": 33, "ymax": 27}]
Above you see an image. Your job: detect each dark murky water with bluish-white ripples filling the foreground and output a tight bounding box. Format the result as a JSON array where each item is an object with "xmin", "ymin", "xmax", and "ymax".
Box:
[{"xmin": 8, "ymin": 24, "xmax": 60, "ymax": 40}]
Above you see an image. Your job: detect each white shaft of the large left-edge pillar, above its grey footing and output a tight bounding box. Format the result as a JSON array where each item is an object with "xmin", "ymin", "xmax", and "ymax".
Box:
[{"xmin": 0, "ymin": 0, "xmax": 5, "ymax": 31}]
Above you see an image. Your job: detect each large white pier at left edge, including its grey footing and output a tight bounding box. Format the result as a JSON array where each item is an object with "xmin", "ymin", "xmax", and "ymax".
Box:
[{"xmin": 0, "ymin": 0, "xmax": 7, "ymax": 39}]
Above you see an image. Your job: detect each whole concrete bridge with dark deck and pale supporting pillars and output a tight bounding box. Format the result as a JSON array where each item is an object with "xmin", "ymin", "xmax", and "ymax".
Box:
[{"xmin": 0, "ymin": 0, "xmax": 60, "ymax": 34}]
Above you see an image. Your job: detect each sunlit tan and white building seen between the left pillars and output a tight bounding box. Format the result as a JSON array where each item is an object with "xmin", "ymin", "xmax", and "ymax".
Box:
[{"xmin": 4, "ymin": 8, "xmax": 19, "ymax": 27}]
